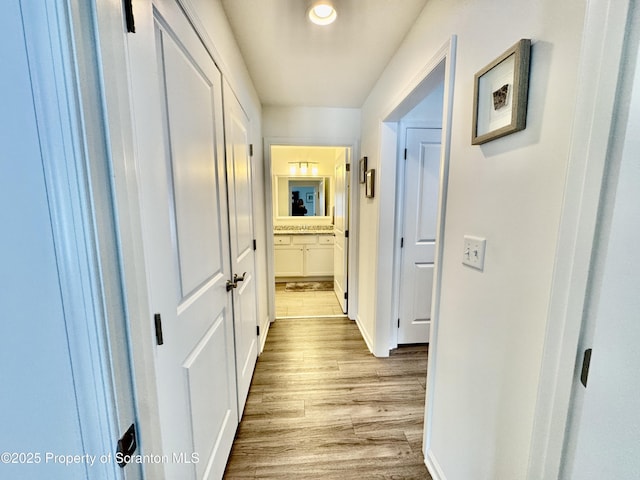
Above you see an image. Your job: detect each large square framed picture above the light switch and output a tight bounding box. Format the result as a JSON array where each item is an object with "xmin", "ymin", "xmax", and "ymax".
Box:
[{"xmin": 471, "ymin": 38, "xmax": 531, "ymax": 145}]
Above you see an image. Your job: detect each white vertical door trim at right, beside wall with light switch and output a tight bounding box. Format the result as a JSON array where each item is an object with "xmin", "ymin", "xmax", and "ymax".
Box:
[{"xmin": 527, "ymin": 0, "xmax": 629, "ymax": 480}]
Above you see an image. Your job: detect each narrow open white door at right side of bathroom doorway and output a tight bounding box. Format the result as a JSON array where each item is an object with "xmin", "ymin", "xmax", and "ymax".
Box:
[{"xmin": 333, "ymin": 148, "xmax": 349, "ymax": 313}]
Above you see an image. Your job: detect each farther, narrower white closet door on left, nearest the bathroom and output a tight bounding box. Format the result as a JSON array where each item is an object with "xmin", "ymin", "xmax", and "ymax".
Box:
[{"xmin": 224, "ymin": 82, "xmax": 258, "ymax": 415}]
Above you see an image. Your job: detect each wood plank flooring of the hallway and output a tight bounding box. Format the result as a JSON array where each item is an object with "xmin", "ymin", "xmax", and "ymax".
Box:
[{"xmin": 224, "ymin": 318, "xmax": 431, "ymax": 480}]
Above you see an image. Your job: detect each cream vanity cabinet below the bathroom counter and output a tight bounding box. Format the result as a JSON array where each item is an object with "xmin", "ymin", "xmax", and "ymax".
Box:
[{"xmin": 274, "ymin": 235, "xmax": 333, "ymax": 277}]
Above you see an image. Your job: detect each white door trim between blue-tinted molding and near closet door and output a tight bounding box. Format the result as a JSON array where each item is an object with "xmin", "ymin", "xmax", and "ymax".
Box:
[{"xmin": 87, "ymin": 0, "xmax": 169, "ymax": 478}]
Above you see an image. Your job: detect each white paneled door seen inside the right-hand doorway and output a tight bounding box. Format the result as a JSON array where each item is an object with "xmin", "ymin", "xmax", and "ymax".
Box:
[{"xmin": 398, "ymin": 128, "xmax": 442, "ymax": 344}]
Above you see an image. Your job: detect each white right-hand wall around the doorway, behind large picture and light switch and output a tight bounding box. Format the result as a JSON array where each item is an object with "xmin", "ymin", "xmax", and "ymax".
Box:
[{"xmin": 359, "ymin": 0, "xmax": 585, "ymax": 480}]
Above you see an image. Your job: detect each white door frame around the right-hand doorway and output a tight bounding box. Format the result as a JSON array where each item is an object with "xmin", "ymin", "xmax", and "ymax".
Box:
[{"xmin": 374, "ymin": 35, "xmax": 457, "ymax": 471}]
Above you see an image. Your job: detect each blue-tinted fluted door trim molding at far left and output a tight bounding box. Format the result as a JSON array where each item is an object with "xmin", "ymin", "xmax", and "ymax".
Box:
[{"xmin": 21, "ymin": 0, "xmax": 142, "ymax": 479}]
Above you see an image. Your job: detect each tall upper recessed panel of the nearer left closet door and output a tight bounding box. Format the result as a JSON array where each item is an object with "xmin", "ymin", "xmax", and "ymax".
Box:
[{"xmin": 163, "ymin": 41, "xmax": 226, "ymax": 297}]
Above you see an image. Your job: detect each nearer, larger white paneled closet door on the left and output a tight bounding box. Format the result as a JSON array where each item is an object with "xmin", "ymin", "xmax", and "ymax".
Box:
[{"xmin": 138, "ymin": 2, "xmax": 238, "ymax": 479}]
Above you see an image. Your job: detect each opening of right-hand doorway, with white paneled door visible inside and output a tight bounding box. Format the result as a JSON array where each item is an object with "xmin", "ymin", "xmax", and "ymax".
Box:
[{"xmin": 391, "ymin": 60, "xmax": 446, "ymax": 345}]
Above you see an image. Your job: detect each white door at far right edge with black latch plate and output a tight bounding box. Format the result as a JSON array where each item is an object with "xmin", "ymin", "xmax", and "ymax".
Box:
[{"xmin": 561, "ymin": 31, "xmax": 640, "ymax": 480}]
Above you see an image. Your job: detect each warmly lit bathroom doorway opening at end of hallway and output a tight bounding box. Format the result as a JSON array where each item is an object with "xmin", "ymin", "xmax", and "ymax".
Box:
[{"xmin": 266, "ymin": 144, "xmax": 352, "ymax": 319}]
